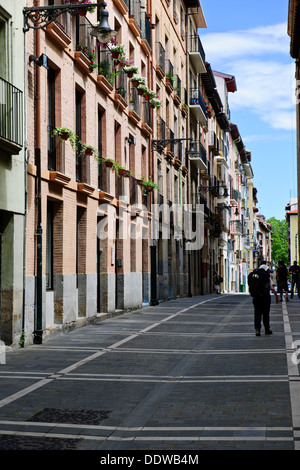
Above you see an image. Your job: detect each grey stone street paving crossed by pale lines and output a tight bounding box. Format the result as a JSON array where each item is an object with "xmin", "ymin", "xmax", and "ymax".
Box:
[{"xmin": 0, "ymin": 294, "xmax": 300, "ymax": 452}]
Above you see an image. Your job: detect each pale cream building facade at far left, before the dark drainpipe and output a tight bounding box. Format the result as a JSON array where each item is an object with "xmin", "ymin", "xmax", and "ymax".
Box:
[{"xmin": 0, "ymin": 0, "xmax": 26, "ymax": 344}]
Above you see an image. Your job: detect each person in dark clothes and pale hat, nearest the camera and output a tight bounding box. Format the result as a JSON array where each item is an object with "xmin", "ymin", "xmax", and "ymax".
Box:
[{"xmin": 248, "ymin": 261, "xmax": 278, "ymax": 336}]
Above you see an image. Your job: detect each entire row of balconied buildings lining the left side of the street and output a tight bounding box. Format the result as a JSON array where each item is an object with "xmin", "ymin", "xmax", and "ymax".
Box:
[{"xmin": 0, "ymin": 0, "xmax": 271, "ymax": 344}]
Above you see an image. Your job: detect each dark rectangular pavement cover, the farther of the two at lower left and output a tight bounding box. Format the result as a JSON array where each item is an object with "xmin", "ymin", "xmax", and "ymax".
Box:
[{"xmin": 26, "ymin": 408, "xmax": 111, "ymax": 424}]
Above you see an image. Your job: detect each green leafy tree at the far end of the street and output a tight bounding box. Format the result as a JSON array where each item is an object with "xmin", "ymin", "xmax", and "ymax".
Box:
[{"xmin": 267, "ymin": 217, "xmax": 289, "ymax": 266}]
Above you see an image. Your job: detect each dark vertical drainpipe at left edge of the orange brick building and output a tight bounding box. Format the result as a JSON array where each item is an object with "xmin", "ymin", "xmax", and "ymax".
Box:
[{"xmin": 33, "ymin": 0, "xmax": 43, "ymax": 344}]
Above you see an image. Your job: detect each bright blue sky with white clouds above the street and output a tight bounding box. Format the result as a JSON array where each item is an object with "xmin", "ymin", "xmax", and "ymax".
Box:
[{"xmin": 199, "ymin": 0, "xmax": 297, "ymax": 219}]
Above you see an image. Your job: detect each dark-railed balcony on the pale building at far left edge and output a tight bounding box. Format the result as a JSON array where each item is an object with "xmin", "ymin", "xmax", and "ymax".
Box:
[{"xmin": 0, "ymin": 78, "xmax": 23, "ymax": 155}]
